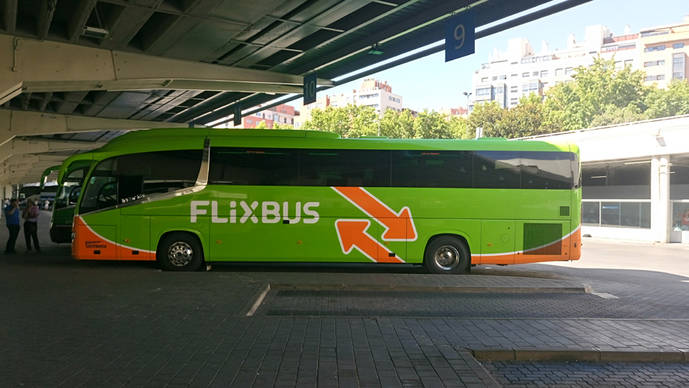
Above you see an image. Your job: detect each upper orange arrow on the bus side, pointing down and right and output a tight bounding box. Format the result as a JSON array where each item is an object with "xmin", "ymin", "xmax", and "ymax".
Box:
[{"xmin": 333, "ymin": 187, "xmax": 416, "ymax": 241}]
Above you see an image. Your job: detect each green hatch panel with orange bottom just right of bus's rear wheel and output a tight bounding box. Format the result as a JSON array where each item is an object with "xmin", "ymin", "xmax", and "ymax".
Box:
[{"xmin": 481, "ymin": 220, "xmax": 515, "ymax": 264}]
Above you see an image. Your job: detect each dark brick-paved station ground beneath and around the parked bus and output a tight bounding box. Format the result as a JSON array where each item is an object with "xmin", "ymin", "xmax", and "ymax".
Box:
[{"xmin": 0, "ymin": 213, "xmax": 689, "ymax": 387}]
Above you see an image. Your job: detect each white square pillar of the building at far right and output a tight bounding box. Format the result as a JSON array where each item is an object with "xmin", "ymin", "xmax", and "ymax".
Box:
[{"xmin": 651, "ymin": 155, "xmax": 671, "ymax": 243}]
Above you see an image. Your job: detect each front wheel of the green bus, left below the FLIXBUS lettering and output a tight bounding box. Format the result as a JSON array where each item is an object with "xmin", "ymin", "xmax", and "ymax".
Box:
[{"xmin": 156, "ymin": 232, "xmax": 203, "ymax": 271}]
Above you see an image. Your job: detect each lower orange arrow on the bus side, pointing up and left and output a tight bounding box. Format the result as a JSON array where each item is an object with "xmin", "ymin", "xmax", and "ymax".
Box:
[{"xmin": 335, "ymin": 220, "xmax": 404, "ymax": 263}]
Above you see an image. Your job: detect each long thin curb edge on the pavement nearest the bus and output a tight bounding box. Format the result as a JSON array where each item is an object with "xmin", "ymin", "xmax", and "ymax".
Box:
[{"xmin": 270, "ymin": 283, "xmax": 590, "ymax": 294}]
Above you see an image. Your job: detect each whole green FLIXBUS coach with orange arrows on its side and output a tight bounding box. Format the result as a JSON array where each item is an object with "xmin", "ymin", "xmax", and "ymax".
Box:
[{"xmin": 63, "ymin": 129, "xmax": 581, "ymax": 273}]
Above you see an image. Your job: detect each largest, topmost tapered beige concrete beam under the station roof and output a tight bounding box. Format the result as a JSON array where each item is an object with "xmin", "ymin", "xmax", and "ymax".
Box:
[{"xmin": 0, "ymin": 35, "xmax": 332, "ymax": 105}]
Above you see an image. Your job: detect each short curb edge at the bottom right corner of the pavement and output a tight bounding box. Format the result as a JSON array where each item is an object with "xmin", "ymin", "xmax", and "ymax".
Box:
[{"xmin": 471, "ymin": 349, "xmax": 689, "ymax": 363}]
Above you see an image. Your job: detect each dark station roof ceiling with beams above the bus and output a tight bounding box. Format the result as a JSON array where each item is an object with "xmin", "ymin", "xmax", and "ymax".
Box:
[{"xmin": 0, "ymin": 0, "xmax": 588, "ymax": 180}]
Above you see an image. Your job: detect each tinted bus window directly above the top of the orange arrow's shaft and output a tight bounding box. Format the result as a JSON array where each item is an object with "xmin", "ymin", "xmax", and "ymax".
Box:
[{"xmin": 299, "ymin": 150, "xmax": 390, "ymax": 186}]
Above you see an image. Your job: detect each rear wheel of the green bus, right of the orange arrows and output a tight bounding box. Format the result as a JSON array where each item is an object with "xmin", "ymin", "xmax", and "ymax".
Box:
[{"xmin": 423, "ymin": 236, "xmax": 471, "ymax": 274}]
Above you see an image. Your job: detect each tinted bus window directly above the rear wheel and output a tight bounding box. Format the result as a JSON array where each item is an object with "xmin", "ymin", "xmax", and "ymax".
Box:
[{"xmin": 392, "ymin": 151, "xmax": 472, "ymax": 187}]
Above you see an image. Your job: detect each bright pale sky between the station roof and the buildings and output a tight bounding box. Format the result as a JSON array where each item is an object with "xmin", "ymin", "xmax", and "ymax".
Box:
[{"xmin": 304, "ymin": 0, "xmax": 689, "ymax": 111}]
